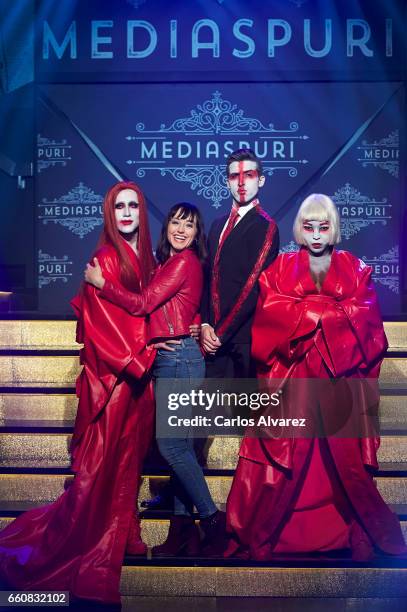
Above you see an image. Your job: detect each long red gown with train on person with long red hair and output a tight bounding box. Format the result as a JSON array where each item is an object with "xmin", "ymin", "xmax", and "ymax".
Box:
[{"xmin": 0, "ymin": 240, "xmax": 154, "ymax": 603}]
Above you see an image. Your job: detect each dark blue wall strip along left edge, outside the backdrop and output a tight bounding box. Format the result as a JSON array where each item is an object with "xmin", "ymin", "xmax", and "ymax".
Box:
[{"xmin": 0, "ymin": 0, "xmax": 34, "ymax": 309}]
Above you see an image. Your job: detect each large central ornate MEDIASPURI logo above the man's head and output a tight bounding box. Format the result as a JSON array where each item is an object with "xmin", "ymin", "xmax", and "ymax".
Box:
[{"xmin": 126, "ymin": 91, "xmax": 309, "ymax": 208}]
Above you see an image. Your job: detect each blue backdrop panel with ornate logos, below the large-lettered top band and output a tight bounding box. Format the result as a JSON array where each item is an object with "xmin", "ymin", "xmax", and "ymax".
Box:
[{"xmin": 36, "ymin": 82, "xmax": 405, "ymax": 316}]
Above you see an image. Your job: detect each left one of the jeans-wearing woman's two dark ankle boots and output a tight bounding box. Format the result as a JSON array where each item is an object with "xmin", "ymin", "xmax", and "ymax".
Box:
[{"xmin": 151, "ymin": 516, "xmax": 199, "ymax": 557}]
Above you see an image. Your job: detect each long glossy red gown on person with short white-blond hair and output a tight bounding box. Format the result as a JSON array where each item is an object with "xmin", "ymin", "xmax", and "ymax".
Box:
[{"xmin": 226, "ymin": 248, "xmax": 406, "ymax": 560}]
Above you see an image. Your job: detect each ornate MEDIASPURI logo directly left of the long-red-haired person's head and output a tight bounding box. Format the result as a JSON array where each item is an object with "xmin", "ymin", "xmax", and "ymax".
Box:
[{"xmin": 38, "ymin": 182, "xmax": 103, "ymax": 238}]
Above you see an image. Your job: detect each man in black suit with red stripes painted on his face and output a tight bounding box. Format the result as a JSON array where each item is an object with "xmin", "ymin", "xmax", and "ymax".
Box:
[{"xmin": 201, "ymin": 149, "xmax": 279, "ymax": 378}]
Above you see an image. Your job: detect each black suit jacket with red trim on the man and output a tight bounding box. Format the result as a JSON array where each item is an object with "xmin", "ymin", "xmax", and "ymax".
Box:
[{"xmin": 201, "ymin": 208, "xmax": 280, "ymax": 344}]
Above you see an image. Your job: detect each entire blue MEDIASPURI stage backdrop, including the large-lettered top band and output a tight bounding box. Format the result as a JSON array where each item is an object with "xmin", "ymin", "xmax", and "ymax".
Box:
[{"xmin": 35, "ymin": 0, "xmax": 406, "ymax": 317}]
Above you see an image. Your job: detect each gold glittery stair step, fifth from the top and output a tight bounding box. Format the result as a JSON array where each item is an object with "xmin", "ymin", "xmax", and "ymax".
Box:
[{"xmin": 0, "ymin": 473, "xmax": 407, "ymax": 508}]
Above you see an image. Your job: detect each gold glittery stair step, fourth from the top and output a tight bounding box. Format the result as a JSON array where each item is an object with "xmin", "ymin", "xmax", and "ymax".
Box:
[{"xmin": 0, "ymin": 433, "xmax": 407, "ymax": 472}]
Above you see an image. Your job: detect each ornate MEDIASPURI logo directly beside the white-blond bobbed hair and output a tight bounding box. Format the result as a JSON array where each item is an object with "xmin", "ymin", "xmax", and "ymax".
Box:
[{"xmin": 332, "ymin": 183, "xmax": 392, "ymax": 240}]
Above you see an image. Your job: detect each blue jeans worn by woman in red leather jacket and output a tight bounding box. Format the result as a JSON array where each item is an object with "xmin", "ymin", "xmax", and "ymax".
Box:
[{"xmin": 153, "ymin": 338, "xmax": 217, "ymax": 518}]
